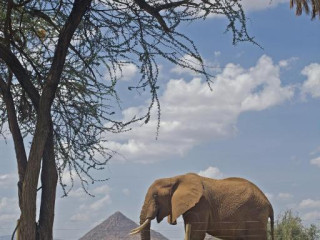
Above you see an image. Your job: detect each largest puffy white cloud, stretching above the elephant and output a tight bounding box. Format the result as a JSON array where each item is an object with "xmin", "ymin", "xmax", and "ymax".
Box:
[{"xmin": 107, "ymin": 55, "xmax": 294, "ymax": 162}]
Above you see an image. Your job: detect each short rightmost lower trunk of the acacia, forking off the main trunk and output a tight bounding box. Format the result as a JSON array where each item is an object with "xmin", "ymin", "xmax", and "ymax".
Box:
[{"xmin": 37, "ymin": 123, "xmax": 58, "ymax": 240}]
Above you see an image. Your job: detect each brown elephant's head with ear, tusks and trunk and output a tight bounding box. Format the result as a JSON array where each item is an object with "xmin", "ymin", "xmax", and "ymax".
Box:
[{"xmin": 131, "ymin": 174, "xmax": 203, "ymax": 240}]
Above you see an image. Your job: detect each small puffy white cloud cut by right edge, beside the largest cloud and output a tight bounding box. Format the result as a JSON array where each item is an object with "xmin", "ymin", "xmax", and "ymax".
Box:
[{"xmin": 301, "ymin": 63, "xmax": 320, "ymax": 98}]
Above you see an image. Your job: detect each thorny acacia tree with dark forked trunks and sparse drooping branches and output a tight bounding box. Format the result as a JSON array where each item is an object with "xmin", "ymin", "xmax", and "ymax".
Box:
[{"xmin": 0, "ymin": 0, "xmax": 254, "ymax": 240}]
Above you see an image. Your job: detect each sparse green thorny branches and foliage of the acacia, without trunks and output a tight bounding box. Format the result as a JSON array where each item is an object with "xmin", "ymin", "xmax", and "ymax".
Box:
[{"xmin": 0, "ymin": 0, "xmax": 253, "ymax": 193}]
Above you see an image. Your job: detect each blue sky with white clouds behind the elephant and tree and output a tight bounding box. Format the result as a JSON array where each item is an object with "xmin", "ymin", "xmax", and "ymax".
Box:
[{"xmin": 0, "ymin": 0, "xmax": 320, "ymax": 239}]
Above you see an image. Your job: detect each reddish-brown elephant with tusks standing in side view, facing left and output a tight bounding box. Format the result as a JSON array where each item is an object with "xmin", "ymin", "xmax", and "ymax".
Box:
[{"xmin": 131, "ymin": 173, "xmax": 274, "ymax": 240}]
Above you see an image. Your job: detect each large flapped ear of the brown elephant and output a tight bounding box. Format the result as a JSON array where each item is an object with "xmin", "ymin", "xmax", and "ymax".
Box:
[{"xmin": 168, "ymin": 174, "xmax": 203, "ymax": 224}]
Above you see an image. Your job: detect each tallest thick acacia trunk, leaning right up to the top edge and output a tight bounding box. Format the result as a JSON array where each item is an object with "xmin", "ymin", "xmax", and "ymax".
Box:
[{"xmin": 19, "ymin": 0, "xmax": 91, "ymax": 240}]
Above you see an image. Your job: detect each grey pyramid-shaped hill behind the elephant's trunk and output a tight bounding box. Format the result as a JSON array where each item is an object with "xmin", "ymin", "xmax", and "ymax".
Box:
[{"xmin": 79, "ymin": 212, "xmax": 168, "ymax": 240}]
